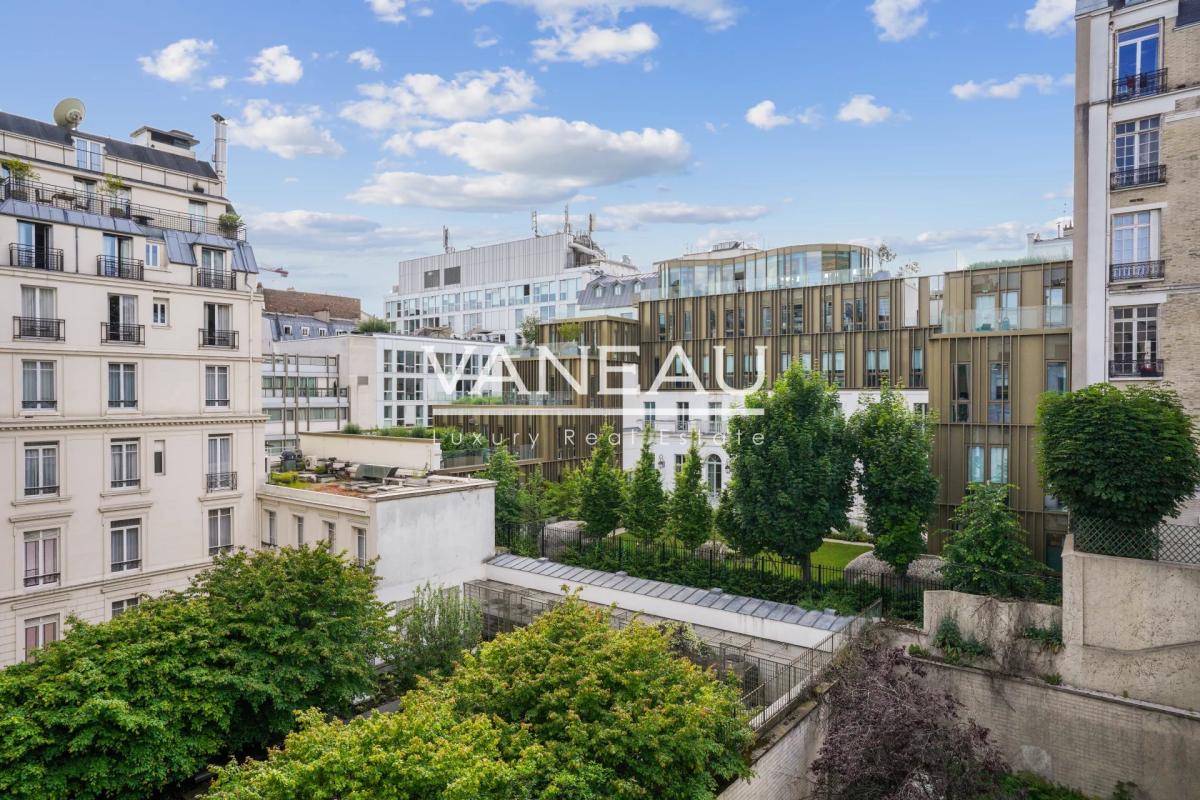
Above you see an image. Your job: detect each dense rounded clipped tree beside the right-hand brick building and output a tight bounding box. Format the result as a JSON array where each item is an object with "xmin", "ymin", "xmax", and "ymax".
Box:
[{"xmin": 1038, "ymin": 384, "xmax": 1200, "ymax": 535}]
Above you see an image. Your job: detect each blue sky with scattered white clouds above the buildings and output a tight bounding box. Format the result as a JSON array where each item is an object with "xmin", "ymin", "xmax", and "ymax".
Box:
[{"xmin": 0, "ymin": 0, "xmax": 1074, "ymax": 311}]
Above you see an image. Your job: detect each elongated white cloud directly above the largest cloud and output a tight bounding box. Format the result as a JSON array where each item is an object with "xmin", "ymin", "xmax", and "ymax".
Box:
[{"xmin": 340, "ymin": 67, "xmax": 538, "ymax": 131}]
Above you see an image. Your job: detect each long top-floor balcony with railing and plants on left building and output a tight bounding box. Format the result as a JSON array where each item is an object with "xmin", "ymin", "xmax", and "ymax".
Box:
[{"xmin": 0, "ymin": 178, "xmax": 246, "ymax": 241}]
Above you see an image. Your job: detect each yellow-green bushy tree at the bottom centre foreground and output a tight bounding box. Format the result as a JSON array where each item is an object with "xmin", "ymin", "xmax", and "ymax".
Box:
[{"xmin": 206, "ymin": 597, "xmax": 751, "ymax": 800}]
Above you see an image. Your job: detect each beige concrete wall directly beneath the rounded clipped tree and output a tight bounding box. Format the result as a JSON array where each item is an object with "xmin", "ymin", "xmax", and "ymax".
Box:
[{"xmin": 1061, "ymin": 539, "xmax": 1200, "ymax": 709}]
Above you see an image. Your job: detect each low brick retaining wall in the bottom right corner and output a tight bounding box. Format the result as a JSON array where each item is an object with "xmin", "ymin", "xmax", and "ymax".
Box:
[{"xmin": 924, "ymin": 662, "xmax": 1200, "ymax": 800}]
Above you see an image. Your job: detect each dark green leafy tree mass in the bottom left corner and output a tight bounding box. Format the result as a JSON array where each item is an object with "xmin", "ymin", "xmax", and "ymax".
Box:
[{"xmin": 0, "ymin": 545, "xmax": 394, "ymax": 800}]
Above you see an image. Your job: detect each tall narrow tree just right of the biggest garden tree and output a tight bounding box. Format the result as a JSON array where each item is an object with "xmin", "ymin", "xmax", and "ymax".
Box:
[{"xmin": 850, "ymin": 381, "xmax": 937, "ymax": 576}]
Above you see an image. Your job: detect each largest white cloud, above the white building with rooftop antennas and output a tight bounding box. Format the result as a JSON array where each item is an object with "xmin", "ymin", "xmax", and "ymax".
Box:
[{"xmin": 350, "ymin": 116, "xmax": 691, "ymax": 210}]
